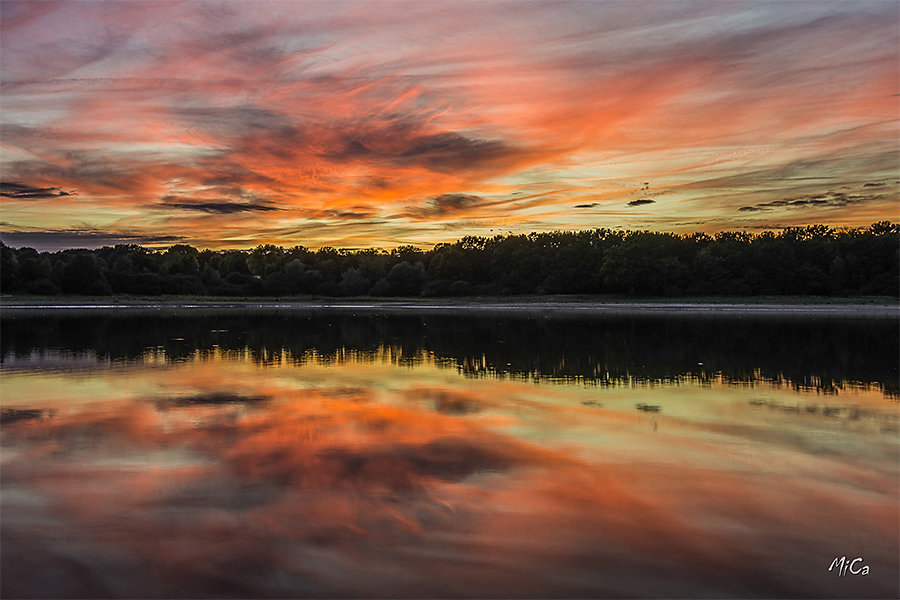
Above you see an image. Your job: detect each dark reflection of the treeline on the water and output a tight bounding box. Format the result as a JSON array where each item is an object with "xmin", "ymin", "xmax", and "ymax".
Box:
[{"xmin": 0, "ymin": 312, "xmax": 900, "ymax": 399}]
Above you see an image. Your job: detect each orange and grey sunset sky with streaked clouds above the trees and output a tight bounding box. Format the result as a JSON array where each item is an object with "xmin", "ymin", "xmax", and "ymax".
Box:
[{"xmin": 0, "ymin": 0, "xmax": 900, "ymax": 250}]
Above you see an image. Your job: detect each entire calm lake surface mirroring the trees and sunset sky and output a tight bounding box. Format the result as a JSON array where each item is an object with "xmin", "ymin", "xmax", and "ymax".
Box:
[{"xmin": 0, "ymin": 312, "xmax": 900, "ymax": 598}]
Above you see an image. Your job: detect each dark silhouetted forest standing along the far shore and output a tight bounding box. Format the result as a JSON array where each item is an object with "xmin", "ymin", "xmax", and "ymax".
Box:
[{"xmin": 0, "ymin": 221, "xmax": 900, "ymax": 297}]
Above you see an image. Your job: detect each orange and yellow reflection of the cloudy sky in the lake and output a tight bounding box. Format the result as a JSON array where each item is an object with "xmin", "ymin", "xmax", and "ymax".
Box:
[{"xmin": 2, "ymin": 353, "xmax": 898, "ymax": 597}]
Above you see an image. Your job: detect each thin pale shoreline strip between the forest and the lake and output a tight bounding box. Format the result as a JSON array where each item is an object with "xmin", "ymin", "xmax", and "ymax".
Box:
[{"xmin": 0, "ymin": 297, "xmax": 900, "ymax": 319}]
